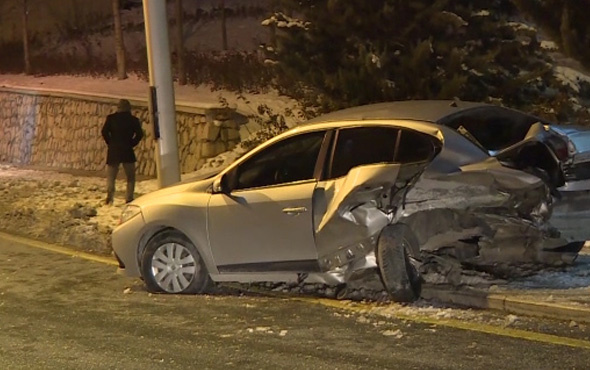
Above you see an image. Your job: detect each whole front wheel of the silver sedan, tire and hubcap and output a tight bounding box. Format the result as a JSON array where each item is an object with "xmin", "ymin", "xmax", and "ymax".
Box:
[{"xmin": 141, "ymin": 229, "xmax": 212, "ymax": 294}]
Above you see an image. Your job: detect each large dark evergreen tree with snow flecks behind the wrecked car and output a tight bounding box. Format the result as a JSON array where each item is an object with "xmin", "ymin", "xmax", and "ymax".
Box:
[{"xmin": 267, "ymin": 0, "xmax": 549, "ymax": 110}]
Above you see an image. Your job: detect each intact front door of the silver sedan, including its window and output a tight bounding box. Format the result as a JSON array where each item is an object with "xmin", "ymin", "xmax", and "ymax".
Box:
[{"xmin": 208, "ymin": 131, "xmax": 325, "ymax": 273}]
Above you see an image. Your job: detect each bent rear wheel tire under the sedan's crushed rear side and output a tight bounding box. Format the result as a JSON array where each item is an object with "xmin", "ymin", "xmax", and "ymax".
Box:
[{"xmin": 376, "ymin": 225, "xmax": 422, "ymax": 302}]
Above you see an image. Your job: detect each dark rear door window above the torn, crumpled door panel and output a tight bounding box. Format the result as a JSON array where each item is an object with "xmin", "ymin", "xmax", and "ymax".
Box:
[{"xmin": 328, "ymin": 127, "xmax": 399, "ymax": 178}]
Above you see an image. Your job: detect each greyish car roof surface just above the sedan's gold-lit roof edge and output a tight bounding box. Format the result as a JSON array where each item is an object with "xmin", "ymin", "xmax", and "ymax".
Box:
[{"xmin": 307, "ymin": 100, "xmax": 490, "ymax": 124}]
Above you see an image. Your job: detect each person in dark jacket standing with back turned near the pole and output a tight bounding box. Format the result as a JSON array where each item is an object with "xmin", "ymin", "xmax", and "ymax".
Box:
[{"xmin": 101, "ymin": 99, "xmax": 143, "ymax": 204}]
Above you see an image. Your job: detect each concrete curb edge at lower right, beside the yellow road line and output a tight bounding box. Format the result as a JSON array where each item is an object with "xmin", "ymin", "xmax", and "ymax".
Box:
[{"xmin": 422, "ymin": 287, "xmax": 590, "ymax": 324}]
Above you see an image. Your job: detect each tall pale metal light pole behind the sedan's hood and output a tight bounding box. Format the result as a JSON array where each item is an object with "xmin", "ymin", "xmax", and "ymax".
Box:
[{"xmin": 143, "ymin": 0, "xmax": 180, "ymax": 188}]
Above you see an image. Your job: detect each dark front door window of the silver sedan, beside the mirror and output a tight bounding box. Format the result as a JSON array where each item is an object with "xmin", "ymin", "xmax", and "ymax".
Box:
[{"xmin": 235, "ymin": 131, "xmax": 325, "ymax": 190}]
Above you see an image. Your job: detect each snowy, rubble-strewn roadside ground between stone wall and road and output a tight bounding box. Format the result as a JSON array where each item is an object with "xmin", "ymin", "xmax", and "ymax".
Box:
[{"xmin": 0, "ymin": 161, "xmax": 232, "ymax": 255}]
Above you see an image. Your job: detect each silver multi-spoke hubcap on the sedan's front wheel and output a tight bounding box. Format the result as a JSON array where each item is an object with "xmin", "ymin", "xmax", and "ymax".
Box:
[{"xmin": 152, "ymin": 243, "xmax": 198, "ymax": 293}]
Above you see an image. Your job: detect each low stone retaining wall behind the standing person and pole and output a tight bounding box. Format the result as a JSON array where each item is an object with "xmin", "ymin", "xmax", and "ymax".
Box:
[{"xmin": 0, "ymin": 88, "xmax": 247, "ymax": 176}]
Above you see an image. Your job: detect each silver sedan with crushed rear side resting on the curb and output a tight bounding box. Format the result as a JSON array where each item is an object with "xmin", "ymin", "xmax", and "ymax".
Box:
[{"xmin": 112, "ymin": 101, "xmax": 581, "ymax": 301}]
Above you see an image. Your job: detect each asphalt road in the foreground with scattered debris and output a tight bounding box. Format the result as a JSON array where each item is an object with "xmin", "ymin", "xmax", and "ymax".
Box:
[{"xmin": 0, "ymin": 236, "xmax": 590, "ymax": 369}]
